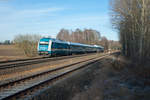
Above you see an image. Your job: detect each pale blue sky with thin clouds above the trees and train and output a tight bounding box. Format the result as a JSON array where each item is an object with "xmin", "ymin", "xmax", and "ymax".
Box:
[{"xmin": 0, "ymin": 0, "xmax": 118, "ymax": 41}]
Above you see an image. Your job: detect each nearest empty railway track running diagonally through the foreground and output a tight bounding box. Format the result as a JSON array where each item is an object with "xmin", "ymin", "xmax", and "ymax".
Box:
[{"xmin": 0, "ymin": 54, "xmax": 109, "ymax": 100}]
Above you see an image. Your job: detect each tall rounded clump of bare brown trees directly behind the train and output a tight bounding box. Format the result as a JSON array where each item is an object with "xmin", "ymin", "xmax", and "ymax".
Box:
[{"xmin": 57, "ymin": 28, "xmax": 101, "ymax": 44}]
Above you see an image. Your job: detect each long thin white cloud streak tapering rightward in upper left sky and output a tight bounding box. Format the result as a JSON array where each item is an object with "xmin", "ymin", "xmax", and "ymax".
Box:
[{"xmin": 0, "ymin": 6, "xmax": 65, "ymax": 23}]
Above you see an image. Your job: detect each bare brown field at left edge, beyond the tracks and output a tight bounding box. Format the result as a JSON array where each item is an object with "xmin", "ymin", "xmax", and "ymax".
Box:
[{"xmin": 0, "ymin": 45, "xmax": 27, "ymax": 61}]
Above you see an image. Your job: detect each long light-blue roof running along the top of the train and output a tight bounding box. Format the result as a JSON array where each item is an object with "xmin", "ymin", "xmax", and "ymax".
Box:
[{"xmin": 40, "ymin": 37, "xmax": 103, "ymax": 48}]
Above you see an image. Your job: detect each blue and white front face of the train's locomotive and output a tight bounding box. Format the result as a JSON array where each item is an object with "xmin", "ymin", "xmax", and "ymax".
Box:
[{"xmin": 37, "ymin": 38, "xmax": 52, "ymax": 56}]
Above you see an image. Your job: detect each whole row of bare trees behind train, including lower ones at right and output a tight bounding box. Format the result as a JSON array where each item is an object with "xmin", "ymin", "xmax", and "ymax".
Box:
[{"xmin": 56, "ymin": 28, "xmax": 120, "ymax": 50}]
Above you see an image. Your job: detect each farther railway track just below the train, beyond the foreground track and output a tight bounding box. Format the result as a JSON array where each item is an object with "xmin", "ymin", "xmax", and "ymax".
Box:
[{"xmin": 0, "ymin": 54, "xmax": 96, "ymax": 70}]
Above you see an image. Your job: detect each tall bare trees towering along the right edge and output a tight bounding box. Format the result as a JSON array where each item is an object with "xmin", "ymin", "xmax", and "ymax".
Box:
[{"xmin": 110, "ymin": 0, "xmax": 150, "ymax": 62}]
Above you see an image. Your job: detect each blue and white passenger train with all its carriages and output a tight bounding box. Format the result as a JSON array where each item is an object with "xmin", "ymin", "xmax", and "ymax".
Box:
[{"xmin": 37, "ymin": 37, "xmax": 104, "ymax": 56}]
